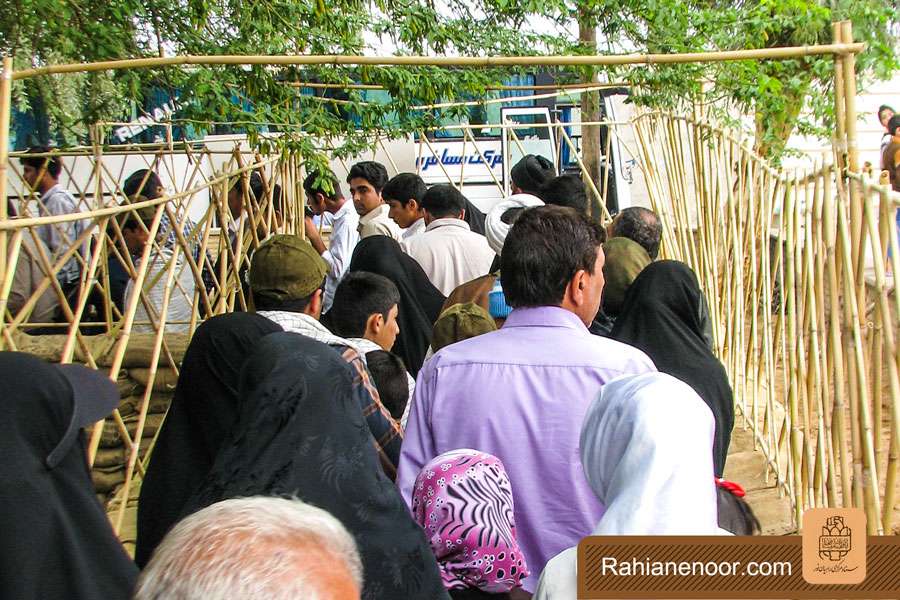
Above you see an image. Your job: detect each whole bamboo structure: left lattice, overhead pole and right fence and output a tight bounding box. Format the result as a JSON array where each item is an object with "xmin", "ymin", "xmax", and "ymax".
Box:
[{"xmin": 0, "ymin": 24, "xmax": 900, "ymax": 548}]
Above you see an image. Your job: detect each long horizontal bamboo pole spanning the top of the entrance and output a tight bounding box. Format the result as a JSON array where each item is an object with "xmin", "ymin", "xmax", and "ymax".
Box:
[{"xmin": 13, "ymin": 44, "xmax": 866, "ymax": 79}]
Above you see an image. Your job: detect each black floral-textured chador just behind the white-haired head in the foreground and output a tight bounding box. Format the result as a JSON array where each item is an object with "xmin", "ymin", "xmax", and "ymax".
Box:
[{"xmin": 184, "ymin": 333, "xmax": 447, "ymax": 600}]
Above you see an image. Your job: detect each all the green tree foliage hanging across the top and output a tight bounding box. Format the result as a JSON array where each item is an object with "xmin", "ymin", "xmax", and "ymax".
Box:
[{"xmin": 0, "ymin": 0, "xmax": 898, "ymax": 162}]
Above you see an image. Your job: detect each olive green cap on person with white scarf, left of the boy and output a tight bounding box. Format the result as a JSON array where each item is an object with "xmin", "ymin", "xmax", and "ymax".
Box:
[{"xmin": 250, "ymin": 234, "xmax": 328, "ymax": 302}]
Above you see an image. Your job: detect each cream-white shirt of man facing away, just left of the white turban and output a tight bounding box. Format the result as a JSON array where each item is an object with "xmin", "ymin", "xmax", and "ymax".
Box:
[{"xmin": 401, "ymin": 217, "xmax": 496, "ymax": 296}]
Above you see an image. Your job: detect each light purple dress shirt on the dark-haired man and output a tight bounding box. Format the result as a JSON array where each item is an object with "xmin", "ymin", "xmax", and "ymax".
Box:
[{"xmin": 397, "ymin": 306, "xmax": 656, "ymax": 591}]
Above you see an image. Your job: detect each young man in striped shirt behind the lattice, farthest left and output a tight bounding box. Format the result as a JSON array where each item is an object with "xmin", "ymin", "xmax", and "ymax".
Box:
[{"xmin": 19, "ymin": 146, "xmax": 88, "ymax": 305}]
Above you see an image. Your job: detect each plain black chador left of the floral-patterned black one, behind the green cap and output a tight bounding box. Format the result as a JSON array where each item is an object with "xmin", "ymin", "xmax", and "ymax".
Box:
[{"xmin": 135, "ymin": 313, "xmax": 281, "ymax": 568}]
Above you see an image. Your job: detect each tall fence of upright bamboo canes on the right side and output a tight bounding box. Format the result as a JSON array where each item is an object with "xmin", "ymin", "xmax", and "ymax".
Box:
[{"xmin": 634, "ymin": 108, "xmax": 900, "ymax": 534}]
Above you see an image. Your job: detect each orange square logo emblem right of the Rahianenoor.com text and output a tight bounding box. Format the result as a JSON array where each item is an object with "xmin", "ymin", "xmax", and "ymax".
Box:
[{"xmin": 803, "ymin": 508, "xmax": 866, "ymax": 584}]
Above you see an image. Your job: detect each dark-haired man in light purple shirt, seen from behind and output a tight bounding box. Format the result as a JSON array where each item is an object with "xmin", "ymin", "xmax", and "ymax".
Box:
[{"xmin": 397, "ymin": 206, "xmax": 656, "ymax": 591}]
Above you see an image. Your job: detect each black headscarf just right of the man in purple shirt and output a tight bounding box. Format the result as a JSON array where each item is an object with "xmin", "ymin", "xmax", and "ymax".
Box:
[{"xmin": 611, "ymin": 260, "xmax": 734, "ymax": 477}]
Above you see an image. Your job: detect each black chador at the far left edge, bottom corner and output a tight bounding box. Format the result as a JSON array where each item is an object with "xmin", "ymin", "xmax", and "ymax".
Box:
[{"xmin": 0, "ymin": 352, "xmax": 138, "ymax": 600}]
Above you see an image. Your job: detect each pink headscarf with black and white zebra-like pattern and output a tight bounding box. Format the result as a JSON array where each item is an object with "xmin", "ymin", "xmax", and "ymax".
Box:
[{"xmin": 412, "ymin": 449, "xmax": 528, "ymax": 593}]
